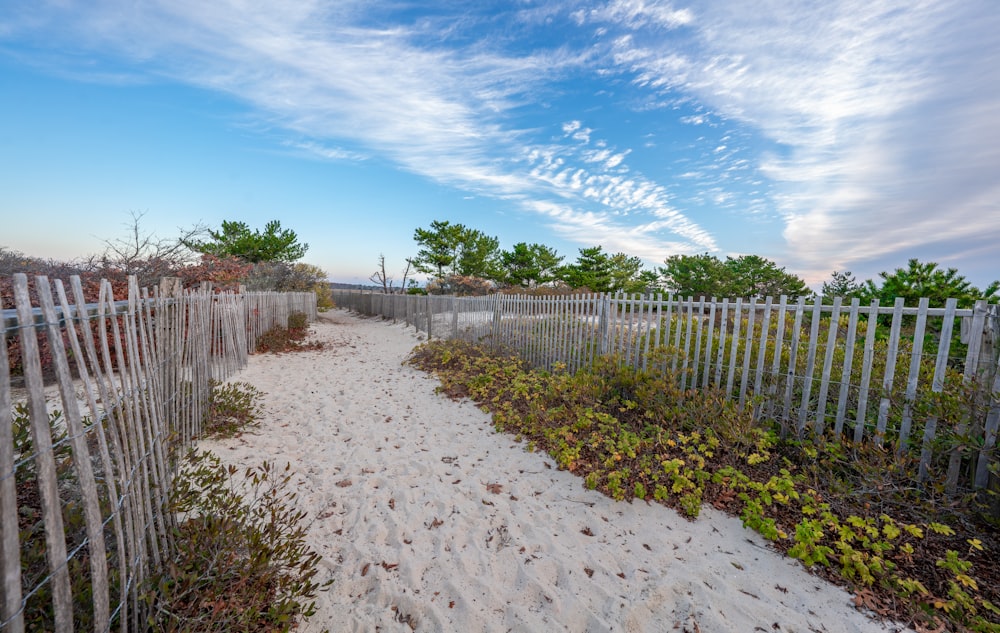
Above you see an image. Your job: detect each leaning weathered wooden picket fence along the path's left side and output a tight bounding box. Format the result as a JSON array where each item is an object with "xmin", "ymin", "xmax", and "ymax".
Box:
[{"xmin": 0, "ymin": 274, "xmax": 316, "ymax": 633}]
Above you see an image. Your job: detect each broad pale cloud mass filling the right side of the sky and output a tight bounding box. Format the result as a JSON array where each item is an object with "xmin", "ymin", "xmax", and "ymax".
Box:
[{"xmin": 590, "ymin": 0, "xmax": 1000, "ymax": 278}]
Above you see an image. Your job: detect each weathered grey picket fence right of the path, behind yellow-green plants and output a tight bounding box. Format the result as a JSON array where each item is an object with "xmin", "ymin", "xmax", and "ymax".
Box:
[{"xmin": 333, "ymin": 291, "xmax": 1000, "ymax": 492}]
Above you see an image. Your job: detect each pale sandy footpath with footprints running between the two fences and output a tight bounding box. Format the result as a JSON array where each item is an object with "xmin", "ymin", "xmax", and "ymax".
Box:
[{"xmin": 197, "ymin": 311, "xmax": 900, "ymax": 633}]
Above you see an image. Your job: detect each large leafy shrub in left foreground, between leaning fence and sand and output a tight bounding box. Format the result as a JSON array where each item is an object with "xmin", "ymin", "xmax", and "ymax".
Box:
[{"xmin": 144, "ymin": 452, "xmax": 329, "ymax": 632}]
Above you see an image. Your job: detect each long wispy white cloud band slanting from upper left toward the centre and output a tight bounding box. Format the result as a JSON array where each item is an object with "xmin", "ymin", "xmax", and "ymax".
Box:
[{"xmin": 1, "ymin": 0, "xmax": 714, "ymax": 260}]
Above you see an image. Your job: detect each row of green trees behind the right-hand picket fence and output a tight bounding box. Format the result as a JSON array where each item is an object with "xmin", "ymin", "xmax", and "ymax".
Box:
[{"xmin": 371, "ymin": 220, "xmax": 1000, "ymax": 307}]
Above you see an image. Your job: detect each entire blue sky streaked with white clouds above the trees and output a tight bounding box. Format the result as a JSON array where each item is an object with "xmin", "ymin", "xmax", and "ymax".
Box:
[{"xmin": 0, "ymin": 0, "xmax": 1000, "ymax": 288}]
